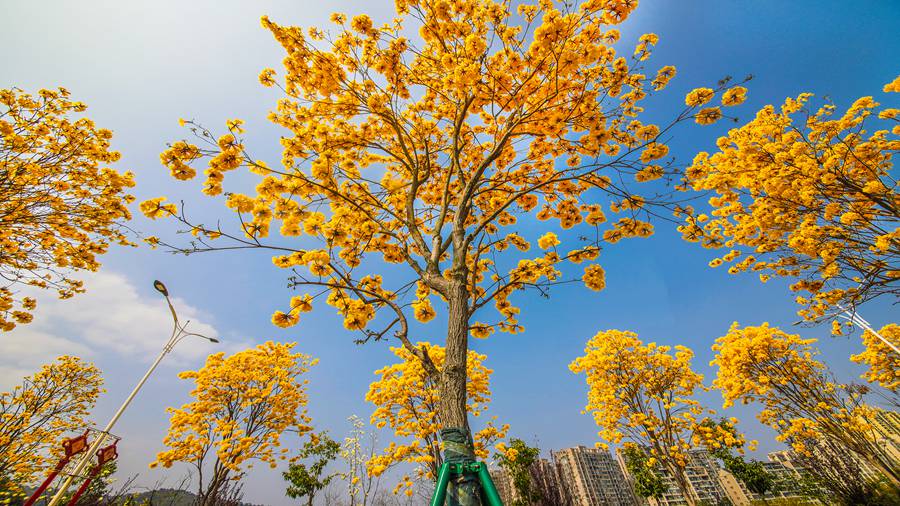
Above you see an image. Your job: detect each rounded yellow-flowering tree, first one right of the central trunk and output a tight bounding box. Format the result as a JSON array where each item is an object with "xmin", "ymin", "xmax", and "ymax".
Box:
[{"xmin": 569, "ymin": 330, "xmax": 744, "ymax": 506}]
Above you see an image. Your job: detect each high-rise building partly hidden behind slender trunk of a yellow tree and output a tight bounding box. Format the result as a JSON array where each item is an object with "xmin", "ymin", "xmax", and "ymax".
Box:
[{"xmin": 616, "ymin": 450, "xmax": 728, "ymax": 506}]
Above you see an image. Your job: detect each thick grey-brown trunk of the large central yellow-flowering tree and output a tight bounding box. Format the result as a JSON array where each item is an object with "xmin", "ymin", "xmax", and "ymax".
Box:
[{"xmin": 438, "ymin": 280, "xmax": 481, "ymax": 506}]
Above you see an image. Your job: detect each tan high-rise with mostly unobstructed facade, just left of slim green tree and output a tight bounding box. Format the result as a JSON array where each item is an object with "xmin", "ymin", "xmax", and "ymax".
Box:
[{"xmin": 553, "ymin": 446, "xmax": 637, "ymax": 506}]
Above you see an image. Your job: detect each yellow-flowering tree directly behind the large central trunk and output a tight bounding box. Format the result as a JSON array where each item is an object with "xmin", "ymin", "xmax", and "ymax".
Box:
[{"xmin": 366, "ymin": 342, "xmax": 509, "ymax": 494}]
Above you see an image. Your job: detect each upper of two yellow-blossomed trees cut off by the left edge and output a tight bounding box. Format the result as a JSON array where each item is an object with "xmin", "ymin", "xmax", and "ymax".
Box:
[{"xmin": 0, "ymin": 88, "xmax": 134, "ymax": 331}]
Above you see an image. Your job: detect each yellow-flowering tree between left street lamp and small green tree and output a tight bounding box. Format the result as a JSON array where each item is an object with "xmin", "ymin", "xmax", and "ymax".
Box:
[{"xmin": 156, "ymin": 341, "xmax": 316, "ymax": 504}]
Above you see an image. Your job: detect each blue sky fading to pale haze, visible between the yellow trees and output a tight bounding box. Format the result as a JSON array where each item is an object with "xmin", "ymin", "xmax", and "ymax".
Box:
[{"xmin": 0, "ymin": 0, "xmax": 900, "ymax": 504}]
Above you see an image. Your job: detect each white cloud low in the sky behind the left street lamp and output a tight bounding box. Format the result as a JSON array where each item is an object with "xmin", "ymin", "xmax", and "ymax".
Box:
[{"xmin": 0, "ymin": 271, "xmax": 247, "ymax": 388}]
